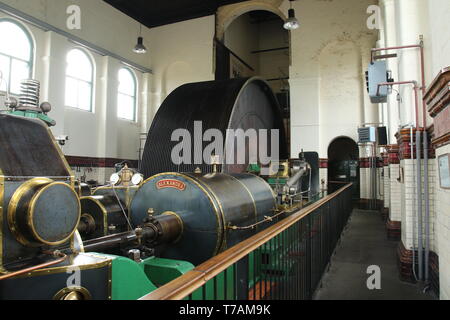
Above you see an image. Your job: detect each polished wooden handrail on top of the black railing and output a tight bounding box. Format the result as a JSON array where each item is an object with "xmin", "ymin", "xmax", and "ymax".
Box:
[{"xmin": 139, "ymin": 183, "xmax": 353, "ymax": 300}]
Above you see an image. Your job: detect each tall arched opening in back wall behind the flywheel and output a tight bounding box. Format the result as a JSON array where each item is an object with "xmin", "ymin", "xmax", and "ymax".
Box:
[{"xmin": 215, "ymin": 9, "xmax": 291, "ymax": 151}]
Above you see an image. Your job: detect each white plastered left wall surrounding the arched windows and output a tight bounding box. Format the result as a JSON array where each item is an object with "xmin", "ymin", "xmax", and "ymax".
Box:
[{"xmin": 0, "ymin": 0, "xmax": 151, "ymax": 168}]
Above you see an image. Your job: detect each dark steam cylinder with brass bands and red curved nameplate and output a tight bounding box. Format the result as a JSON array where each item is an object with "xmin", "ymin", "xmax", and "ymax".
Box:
[{"xmin": 131, "ymin": 173, "xmax": 276, "ymax": 265}]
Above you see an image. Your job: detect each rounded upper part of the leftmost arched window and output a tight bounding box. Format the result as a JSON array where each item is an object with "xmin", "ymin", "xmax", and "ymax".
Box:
[{"xmin": 0, "ymin": 21, "xmax": 32, "ymax": 61}]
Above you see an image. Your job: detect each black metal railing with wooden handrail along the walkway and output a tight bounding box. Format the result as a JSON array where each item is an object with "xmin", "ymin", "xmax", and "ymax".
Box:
[{"xmin": 142, "ymin": 184, "xmax": 353, "ymax": 301}]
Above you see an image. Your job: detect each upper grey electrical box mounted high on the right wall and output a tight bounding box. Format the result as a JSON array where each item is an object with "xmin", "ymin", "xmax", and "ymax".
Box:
[{"xmin": 366, "ymin": 61, "xmax": 392, "ymax": 103}]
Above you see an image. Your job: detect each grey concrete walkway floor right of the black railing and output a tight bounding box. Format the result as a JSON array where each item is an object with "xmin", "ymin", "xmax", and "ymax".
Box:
[{"xmin": 314, "ymin": 210, "xmax": 433, "ymax": 300}]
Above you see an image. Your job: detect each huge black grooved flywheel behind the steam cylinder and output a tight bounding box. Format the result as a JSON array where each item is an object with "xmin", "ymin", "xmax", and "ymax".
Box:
[{"xmin": 140, "ymin": 78, "xmax": 288, "ymax": 178}]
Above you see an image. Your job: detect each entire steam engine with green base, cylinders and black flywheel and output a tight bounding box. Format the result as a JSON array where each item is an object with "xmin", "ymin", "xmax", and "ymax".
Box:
[{"xmin": 0, "ymin": 79, "xmax": 319, "ymax": 300}]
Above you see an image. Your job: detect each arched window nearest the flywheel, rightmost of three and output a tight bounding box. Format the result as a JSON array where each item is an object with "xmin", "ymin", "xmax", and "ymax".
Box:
[{"xmin": 117, "ymin": 68, "xmax": 137, "ymax": 121}]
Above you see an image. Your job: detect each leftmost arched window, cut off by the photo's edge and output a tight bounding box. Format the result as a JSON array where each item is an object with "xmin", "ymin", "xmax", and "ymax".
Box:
[{"xmin": 0, "ymin": 19, "xmax": 34, "ymax": 94}]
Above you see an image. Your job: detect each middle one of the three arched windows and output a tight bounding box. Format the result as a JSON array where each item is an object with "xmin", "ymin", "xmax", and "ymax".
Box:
[{"xmin": 65, "ymin": 49, "xmax": 94, "ymax": 111}]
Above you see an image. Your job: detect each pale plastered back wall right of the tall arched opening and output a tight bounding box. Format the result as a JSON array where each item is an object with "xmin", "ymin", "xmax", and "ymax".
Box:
[{"xmin": 284, "ymin": 0, "xmax": 378, "ymax": 158}]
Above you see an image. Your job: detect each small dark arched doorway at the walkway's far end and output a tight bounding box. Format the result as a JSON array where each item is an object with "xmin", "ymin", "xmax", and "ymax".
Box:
[{"xmin": 328, "ymin": 137, "xmax": 360, "ymax": 199}]
